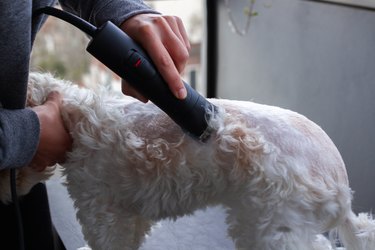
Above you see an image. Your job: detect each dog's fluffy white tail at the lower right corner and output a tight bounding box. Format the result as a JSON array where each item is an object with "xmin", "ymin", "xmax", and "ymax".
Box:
[{"xmin": 338, "ymin": 212, "xmax": 375, "ymax": 250}]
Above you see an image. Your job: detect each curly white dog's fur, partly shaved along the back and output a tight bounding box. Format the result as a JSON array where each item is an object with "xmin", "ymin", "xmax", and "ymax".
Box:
[{"xmin": 0, "ymin": 74, "xmax": 375, "ymax": 250}]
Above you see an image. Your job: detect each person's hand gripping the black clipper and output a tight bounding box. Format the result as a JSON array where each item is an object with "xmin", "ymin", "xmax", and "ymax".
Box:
[{"xmin": 121, "ymin": 14, "xmax": 190, "ymax": 102}]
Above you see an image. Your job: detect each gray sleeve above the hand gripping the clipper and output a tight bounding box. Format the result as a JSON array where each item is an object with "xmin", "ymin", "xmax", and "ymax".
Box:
[{"xmin": 59, "ymin": 0, "xmax": 159, "ymax": 26}]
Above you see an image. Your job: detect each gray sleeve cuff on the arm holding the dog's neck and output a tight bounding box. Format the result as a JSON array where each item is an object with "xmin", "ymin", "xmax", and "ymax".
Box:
[{"xmin": 0, "ymin": 108, "xmax": 40, "ymax": 170}]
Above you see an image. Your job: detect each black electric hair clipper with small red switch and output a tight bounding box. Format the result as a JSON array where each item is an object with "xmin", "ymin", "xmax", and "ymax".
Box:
[{"xmin": 87, "ymin": 22, "xmax": 216, "ymax": 141}]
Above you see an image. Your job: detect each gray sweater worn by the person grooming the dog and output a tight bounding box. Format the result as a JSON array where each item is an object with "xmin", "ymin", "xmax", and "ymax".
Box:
[{"xmin": 0, "ymin": 0, "xmax": 156, "ymax": 170}]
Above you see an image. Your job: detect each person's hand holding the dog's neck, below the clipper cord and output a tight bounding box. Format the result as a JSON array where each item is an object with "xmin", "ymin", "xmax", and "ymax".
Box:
[{"xmin": 29, "ymin": 92, "xmax": 72, "ymax": 171}]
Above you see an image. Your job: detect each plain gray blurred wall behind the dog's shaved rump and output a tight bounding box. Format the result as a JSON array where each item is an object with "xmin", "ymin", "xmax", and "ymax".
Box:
[{"xmin": 214, "ymin": 0, "xmax": 375, "ymax": 211}]
